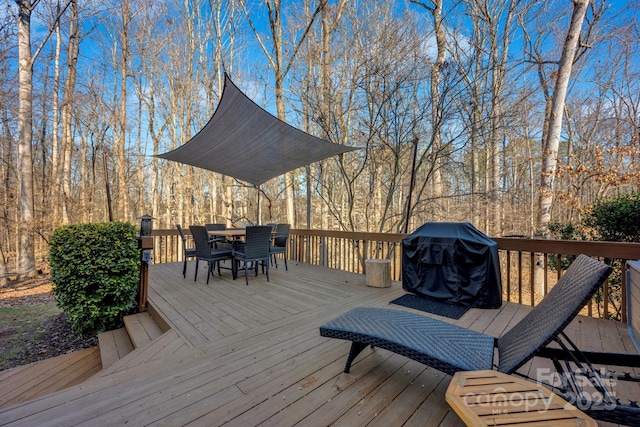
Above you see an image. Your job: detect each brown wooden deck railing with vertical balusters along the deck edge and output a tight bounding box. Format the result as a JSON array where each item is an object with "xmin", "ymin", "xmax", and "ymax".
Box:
[{"xmin": 152, "ymin": 229, "xmax": 640, "ymax": 322}]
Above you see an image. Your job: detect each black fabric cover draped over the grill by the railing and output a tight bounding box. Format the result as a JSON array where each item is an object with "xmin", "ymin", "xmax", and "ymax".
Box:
[{"xmin": 402, "ymin": 222, "xmax": 502, "ymax": 308}]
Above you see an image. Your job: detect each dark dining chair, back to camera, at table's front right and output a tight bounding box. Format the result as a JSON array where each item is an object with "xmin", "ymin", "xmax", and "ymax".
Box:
[{"xmin": 232, "ymin": 225, "xmax": 272, "ymax": 285}]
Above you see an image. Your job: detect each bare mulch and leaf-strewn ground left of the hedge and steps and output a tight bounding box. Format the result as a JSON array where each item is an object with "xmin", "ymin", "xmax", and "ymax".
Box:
[{"xmin": 0, "ymin": 277, "xmax": 97, "ymax": 371}]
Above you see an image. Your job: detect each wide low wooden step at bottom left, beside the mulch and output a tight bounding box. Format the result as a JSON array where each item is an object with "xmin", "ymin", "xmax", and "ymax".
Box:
[{"xmin": 0, "ymin": 347, "xmax": 102, "ymax": 408}]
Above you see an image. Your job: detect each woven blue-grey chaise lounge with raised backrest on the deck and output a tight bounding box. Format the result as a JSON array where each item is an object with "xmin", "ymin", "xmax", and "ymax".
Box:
[{"xmin": 320, "ymin": 255, "xmax": 640, "ymax": 422}]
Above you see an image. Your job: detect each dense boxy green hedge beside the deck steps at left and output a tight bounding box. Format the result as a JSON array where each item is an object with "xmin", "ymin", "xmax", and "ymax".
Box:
[{"xmin": 49, "ymin": 222, "xmax": 140, "ymax": 337}]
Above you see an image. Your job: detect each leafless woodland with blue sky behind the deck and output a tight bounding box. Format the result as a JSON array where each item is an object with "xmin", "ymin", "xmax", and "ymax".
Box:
[{"xmin": 0, "ymin": 0, "xmax": 640, "ymax": 280}]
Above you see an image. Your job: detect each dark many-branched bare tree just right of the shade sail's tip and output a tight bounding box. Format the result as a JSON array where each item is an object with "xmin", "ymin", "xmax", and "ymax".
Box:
[{"xmin": 305, "ymin": 3, "xmax": 440, "ymax": 237}]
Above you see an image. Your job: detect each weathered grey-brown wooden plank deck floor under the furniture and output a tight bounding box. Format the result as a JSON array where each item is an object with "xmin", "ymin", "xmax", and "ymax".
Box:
[{"xmin": 0, "ymin": 262, "xmax": 640, "ymax": 427}]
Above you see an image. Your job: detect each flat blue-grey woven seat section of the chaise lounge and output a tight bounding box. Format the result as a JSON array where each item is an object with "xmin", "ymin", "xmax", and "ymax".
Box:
[{"xmin": 320, "ymin": 307, "xmax": 495, "ymax": 374}]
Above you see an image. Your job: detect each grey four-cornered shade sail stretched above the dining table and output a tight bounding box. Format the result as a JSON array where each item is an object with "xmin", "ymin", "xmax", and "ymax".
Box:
[{"xmin": 158, "ymin": 75, "xmax": 356, "ymax": 186}]
